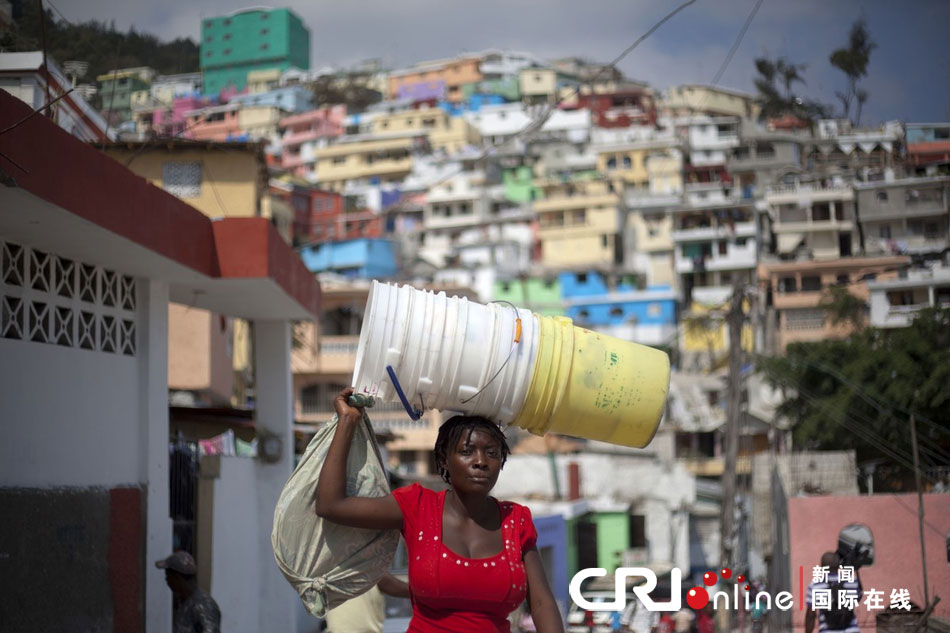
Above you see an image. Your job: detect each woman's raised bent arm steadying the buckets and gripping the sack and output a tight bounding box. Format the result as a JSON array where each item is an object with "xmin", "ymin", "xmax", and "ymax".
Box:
[{"xmin": 316, "ymin": 387, "xmax": 402, "ymax": 529}]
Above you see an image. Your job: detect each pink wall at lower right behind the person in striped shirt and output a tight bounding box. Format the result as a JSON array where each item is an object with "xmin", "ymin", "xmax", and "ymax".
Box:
[{"xmin": 788, "ymin": 494, "xmax": 950, "ymax": 633}]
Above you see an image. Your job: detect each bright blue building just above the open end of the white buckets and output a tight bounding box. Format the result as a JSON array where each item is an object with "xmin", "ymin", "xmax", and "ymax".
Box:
[{"xmin": 300, "ymin": 238, "xmax": 399, "ymax": 279}]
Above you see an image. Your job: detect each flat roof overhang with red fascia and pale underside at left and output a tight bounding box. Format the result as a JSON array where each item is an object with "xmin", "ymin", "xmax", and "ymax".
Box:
[{"xmin": 0, "ymin": 91, "xmax": 320, "ymax": 320}]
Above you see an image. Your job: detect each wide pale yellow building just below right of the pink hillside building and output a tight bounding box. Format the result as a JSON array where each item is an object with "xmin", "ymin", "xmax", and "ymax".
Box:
[{"xmin": 314, "ymin": 132, "xmax": 418, "ymax": 191}]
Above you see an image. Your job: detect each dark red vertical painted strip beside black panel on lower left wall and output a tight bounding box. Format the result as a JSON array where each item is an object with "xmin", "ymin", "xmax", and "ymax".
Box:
[{"xmin": 109, "ymin": 488, "xmax": 145, "ymax": 633}]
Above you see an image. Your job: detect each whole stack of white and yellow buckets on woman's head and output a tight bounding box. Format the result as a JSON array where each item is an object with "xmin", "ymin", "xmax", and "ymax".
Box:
[{"xmin": 353, "ymin": 281, "xmax": 670, "ymax": 448}]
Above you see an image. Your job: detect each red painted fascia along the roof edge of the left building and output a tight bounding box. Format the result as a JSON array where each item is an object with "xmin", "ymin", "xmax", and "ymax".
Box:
[{"xmin": 0, "ymin": 91, "xmax": 320, "ymax": 316}]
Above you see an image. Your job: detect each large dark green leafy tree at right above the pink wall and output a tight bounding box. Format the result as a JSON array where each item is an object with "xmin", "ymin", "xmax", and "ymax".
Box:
[{"xmin": 757, "ymin": 308, "xmax": 950, "ymax": 490}]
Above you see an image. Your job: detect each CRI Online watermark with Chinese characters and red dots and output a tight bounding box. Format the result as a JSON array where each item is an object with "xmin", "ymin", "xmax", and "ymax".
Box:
[{"xmin": 568, "ymin": 565, "xmax": 911, "ymax": 611}]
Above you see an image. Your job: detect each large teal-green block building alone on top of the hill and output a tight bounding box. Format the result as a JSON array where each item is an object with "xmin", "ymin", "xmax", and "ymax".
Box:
[{"xmin": 201, "ymin": 9, "xmax": 310, "ymax": 95}]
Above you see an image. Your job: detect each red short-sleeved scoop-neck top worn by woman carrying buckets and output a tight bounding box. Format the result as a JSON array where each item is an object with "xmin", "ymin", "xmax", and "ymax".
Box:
[{"xmin": 393, "ymin": 484, "xmax": 538, "ymax": 633}]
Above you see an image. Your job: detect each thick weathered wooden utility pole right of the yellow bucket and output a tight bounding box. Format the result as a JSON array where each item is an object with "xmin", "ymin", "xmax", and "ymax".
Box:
[{"xmin": 719, "ymin": 278, "xmax": 745, "ymax": 568}]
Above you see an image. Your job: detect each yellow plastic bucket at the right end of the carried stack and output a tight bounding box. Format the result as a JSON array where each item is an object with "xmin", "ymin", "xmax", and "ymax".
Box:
[{"xmin": 511, "ymin": 315, "xmax": 670, "ymax": 448}]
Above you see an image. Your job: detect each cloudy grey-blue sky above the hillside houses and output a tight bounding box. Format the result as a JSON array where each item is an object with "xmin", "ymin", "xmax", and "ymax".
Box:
[{"xmin": 52, "ymin": 0, "xmax": 950, "ymax": 125}]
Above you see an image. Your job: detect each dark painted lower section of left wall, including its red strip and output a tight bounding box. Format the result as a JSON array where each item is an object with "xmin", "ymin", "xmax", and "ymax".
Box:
[{"xmin": 0, "ymin": 487, "xmax": 144, "ymax": 632}]
